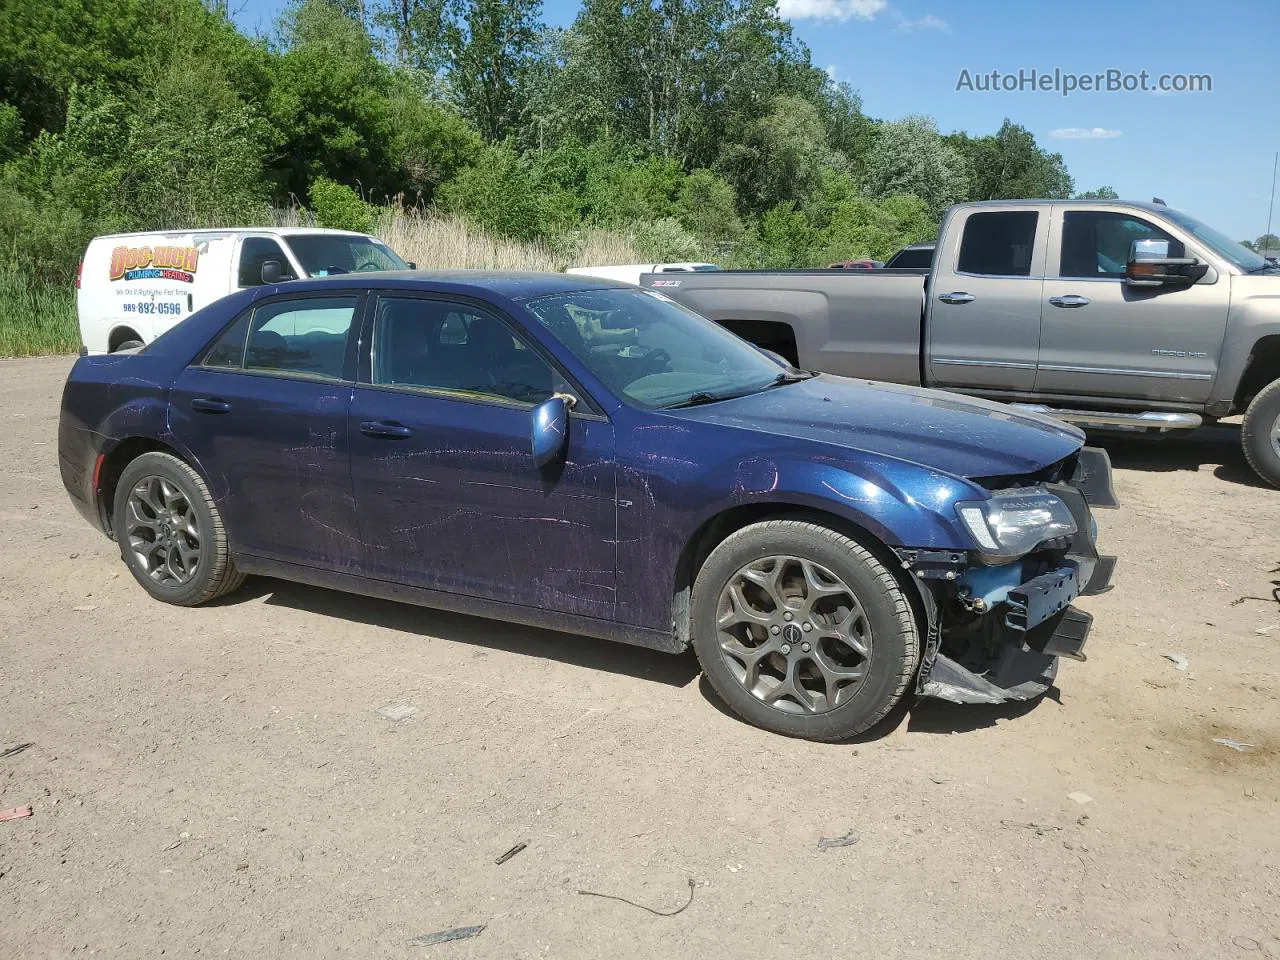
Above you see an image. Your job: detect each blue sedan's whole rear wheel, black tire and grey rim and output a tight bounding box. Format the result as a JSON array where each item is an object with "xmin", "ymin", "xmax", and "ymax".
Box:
[{"xmin": 111, "ymin": 452, "xmax": 244, "ymax": 607}]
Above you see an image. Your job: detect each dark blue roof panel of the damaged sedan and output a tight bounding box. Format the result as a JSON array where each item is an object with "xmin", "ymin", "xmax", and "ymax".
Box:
[{"xmin": 263, "ymin": 270, "xmax": 636, "ymax": 301}]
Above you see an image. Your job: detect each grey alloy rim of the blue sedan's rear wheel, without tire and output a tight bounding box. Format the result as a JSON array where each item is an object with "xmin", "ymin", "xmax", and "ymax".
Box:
[{"xmin": 124, "ymin": 476, "xmax": 201, "ymax": 586}]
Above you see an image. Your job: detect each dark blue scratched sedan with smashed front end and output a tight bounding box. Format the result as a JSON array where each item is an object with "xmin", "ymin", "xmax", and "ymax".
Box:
[{"xmin": 59, "ymin": 273, "xmax": 1115, "ymax": 740}]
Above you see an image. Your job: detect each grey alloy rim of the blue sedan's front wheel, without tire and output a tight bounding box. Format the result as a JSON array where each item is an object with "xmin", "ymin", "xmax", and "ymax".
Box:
[{"xmin": 716, "ymin": 556, "xmax": 872, "ymax": 714}]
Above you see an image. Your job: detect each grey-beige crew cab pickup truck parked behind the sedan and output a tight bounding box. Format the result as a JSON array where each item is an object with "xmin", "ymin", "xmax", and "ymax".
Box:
[{"xmin": 640, "ymin": 200, "xmax": 1280, "ymax": 486}]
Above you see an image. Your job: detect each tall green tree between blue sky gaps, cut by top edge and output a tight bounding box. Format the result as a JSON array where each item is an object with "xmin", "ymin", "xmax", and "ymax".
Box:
[{"xmin": 445, "ymin": 0, "xmax": 541, "ymax": 141}]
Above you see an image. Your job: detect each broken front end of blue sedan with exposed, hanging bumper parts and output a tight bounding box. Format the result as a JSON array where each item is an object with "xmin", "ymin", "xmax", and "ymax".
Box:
[{"xmin": 900, "ymin": 447, "xmax": 1119, "ymax": 704}]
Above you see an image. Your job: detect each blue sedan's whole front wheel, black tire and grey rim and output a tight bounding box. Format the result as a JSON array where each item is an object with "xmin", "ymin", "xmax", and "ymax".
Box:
[{"xmin": 691, "ymin": 520, "xmax": 920, "ymax": 741}]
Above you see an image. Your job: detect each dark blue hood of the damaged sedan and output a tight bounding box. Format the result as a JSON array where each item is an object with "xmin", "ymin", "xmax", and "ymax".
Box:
[{"xmin": 672, "ymin": 374, "xmax": 1084, "ymax": 477}]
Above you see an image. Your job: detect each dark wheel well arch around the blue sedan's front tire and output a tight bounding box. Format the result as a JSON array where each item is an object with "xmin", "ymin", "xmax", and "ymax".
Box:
[{"xmin": 672, "ymin": 503, "xmax": 901, "ymax": 646}]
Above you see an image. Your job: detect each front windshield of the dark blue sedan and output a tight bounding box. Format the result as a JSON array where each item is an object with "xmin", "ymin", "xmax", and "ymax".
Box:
[{"xmin": 525, "ymin": 289, "xmax": 785, "ymax": 407}]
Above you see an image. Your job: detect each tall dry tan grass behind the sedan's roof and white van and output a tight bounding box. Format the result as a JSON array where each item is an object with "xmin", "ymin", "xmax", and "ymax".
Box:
[{"xmin": 271, "ymin": 206, "xmax": 644, "ymax": 273}]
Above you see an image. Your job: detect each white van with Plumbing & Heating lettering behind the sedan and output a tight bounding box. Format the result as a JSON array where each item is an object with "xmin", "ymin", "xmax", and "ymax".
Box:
[{"xmin": 76, "ymin": 227, "xmax": 412, "ymax": 355}]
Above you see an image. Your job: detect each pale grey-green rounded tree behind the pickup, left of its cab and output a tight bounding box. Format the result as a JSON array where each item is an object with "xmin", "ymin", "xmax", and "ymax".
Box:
[{"xmin": 864, "ymin": 115, "xmax": 969, "ymax": 219}]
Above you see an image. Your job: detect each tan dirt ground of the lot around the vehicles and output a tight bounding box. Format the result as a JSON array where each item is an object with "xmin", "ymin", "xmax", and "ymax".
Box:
[{"xmin": 0, "ymin": 358, "xmax": 1280, "ymax": 960}]
